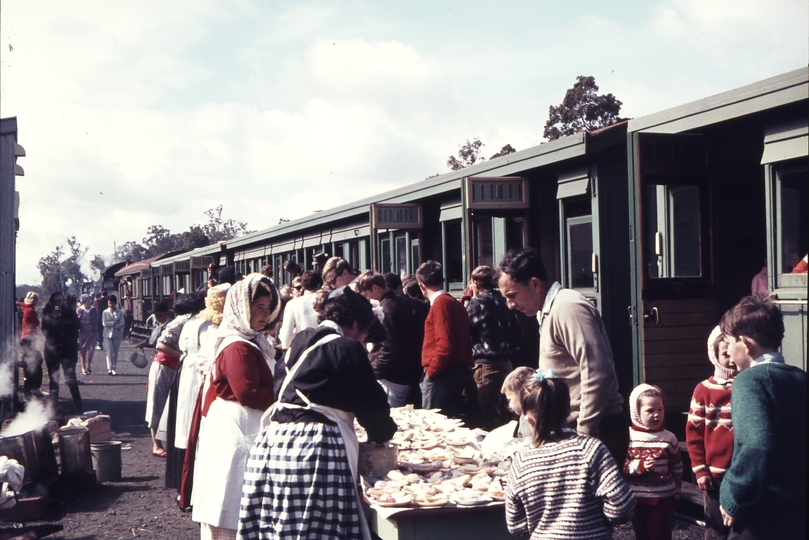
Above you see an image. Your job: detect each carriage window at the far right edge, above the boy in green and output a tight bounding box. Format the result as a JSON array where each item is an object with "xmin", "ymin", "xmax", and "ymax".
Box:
[{"xmin": 776, "ymin": 165, "xmax": 809, "ymax": 287}]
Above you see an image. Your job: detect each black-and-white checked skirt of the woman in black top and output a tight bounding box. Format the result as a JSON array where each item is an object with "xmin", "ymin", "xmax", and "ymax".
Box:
[{"xmin": 238, "ymin": 422, "xmax": 362, "ymax": 540}]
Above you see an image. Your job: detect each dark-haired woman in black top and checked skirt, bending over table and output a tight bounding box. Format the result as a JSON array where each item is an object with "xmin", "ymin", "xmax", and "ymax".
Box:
[{"xmin": 239, "ymin": 287, "xmax": 396, "ymax": 539}]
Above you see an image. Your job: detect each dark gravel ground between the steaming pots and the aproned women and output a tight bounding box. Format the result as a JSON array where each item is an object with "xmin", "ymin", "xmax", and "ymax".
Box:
[{"xmin": 3, "ymin": 343, "xmax": 703, "ymax": 540}]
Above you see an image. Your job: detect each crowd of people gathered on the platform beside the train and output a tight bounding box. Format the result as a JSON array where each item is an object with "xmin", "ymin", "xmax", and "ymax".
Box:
[{"xmin": 11, "ymin": 248, "xmax": 806, "ymax": 539}]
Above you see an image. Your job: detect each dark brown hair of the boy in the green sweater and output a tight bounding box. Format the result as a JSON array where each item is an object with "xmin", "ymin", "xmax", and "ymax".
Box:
[{"xmin": 719, "ymin": 296, "xmax": 784, "ymax": 350}]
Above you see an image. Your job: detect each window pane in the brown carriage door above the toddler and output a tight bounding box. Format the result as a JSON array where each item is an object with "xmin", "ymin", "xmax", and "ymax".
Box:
[{"xmin": 645, "ymin": 184, "xmax": 702, "ymax": 278}]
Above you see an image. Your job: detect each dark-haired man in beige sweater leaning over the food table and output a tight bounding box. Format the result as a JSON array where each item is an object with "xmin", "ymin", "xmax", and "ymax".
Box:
[{"xmin": 499, "ymin": 248, "xmax": 629, "ymax": 463}]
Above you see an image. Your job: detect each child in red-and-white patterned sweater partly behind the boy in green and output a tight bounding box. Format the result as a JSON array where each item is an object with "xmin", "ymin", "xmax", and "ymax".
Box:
[{"xmin": 685, "ymin": 326, "xmax": 739, "ymax": 540}]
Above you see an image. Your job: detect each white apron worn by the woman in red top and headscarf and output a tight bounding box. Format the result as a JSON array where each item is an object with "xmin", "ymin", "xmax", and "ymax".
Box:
[{"xmin": 191, "ymin": 336, "xmax": 275, "ymax": 529}]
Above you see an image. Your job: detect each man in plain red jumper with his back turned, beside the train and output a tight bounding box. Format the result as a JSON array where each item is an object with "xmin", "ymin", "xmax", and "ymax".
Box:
[{"xmin": 416, "ymin": 261, "xmax": 472, "ymax": 417}]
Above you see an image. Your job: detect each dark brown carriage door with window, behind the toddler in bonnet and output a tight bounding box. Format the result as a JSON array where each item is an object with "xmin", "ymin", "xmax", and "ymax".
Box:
[{"xmin": 629, "ymin": 133, "xmax": 718, "ymax": 410}]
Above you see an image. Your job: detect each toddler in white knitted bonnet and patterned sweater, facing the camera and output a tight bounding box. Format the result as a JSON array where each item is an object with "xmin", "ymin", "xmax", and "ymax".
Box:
[{"xmin": 624, "ymin": 383, "xmax": 683, "ymax": 540}]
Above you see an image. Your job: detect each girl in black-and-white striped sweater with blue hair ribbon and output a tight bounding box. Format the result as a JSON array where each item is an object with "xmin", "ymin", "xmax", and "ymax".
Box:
[{"xmin": 506, "ymin": 370, "xmax": 635, "ymax": 540}]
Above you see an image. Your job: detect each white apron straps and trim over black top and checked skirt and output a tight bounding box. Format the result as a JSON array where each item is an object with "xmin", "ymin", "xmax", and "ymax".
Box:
[{"xmin": 261, "ymin": 334, "xmax": 371, "ymax": 540}]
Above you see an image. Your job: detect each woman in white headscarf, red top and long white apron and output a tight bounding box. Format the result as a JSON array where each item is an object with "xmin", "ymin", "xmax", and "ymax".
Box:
[{"xmin": 191, "ymin": 273, "xmax": 280, "ymax": 540}]
